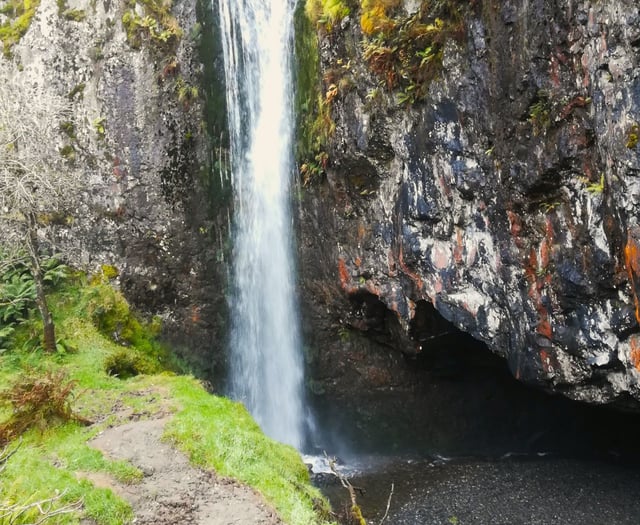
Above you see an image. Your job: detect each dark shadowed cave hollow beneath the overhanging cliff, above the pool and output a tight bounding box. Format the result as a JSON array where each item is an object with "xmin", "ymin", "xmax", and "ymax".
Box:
[{"xmin": 311, "ymin": 295, "xmax": 640, "ymax": 463}]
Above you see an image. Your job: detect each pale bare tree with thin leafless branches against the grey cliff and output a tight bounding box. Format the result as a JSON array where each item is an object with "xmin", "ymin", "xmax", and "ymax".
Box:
[{"xmin": 0, "ymin": 62, "xmax": 78, "ymax": 352}]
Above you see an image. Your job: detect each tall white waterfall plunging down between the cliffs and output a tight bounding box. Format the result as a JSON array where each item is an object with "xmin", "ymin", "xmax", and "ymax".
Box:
[{"xmin": 219, "ymin": 0, "xmax": 304, "ymax": 449}]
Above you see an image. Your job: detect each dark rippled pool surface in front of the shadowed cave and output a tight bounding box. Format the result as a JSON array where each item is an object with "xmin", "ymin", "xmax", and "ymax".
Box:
[{"xmin": 323, "ymin": 456, "xmax": 640, "ymax": 525}]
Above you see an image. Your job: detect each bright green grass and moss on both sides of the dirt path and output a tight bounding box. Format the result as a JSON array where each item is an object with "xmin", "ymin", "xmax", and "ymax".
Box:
[{"xmin": 0, "ymin": 276, "xmax": 328, "ymax": 525}]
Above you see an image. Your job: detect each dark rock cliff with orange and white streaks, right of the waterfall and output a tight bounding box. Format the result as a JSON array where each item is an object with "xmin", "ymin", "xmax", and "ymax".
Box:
[{"xmin": 299, "ymin": 0, "xmax": 640, "ymax": 409}]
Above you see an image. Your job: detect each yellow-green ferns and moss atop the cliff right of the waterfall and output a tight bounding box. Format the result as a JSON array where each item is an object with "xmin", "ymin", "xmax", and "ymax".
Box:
[{"xmin": 296, "ymin": 0, "xmax": 467, "ymax": 184}]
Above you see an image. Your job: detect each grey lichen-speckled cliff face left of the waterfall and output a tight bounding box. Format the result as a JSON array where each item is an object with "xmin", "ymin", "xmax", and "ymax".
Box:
[{"xmin": 0, "ymin": 0, "xmax": 227, "ymax": 373}]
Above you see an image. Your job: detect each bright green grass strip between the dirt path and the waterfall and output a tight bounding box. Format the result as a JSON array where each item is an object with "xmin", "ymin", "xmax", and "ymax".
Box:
[{"xmin": 166, "ymin": 377, "xmax": 329, "ymax": 525}]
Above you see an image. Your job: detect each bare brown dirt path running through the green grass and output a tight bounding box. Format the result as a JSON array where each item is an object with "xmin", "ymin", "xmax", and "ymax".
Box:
[{"xmin": 84, "ymin": 418, "xmax": 282, "ymax": 525}]
